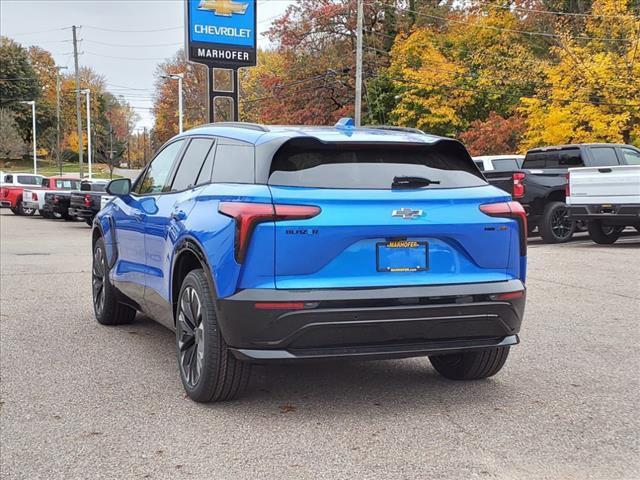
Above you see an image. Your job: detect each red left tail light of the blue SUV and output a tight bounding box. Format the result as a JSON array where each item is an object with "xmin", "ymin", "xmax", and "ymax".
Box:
[{"xmin": 218, "ymin": 202, "xmax": 321, "ymax": 263}]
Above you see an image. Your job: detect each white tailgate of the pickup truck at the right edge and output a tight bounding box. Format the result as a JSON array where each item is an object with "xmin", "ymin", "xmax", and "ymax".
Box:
[{"xmin": 568, "ymin": 165, "xmax": 640, "ymax": 205}]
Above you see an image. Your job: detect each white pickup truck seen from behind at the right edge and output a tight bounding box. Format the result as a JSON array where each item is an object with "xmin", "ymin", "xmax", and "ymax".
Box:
[{"xmin": 567, "ymin": 165, "xmax": 640, "ymax": 244}]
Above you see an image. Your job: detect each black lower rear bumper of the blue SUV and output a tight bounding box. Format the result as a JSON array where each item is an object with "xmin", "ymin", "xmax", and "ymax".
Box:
[{"xmin": 218, "ymin": 280, "xmax": 525, "ymax": 361}]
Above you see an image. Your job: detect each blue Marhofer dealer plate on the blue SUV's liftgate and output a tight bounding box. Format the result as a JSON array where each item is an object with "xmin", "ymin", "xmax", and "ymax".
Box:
[{"xmin": 376, "ymin": 240, "xmax": 429, "ymax": 272}]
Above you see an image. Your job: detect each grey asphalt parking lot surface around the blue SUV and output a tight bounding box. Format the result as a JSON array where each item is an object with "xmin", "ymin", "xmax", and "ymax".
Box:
[{"xmin": 0, "ymin": 210, "xmax": 640, "ymax": 480}]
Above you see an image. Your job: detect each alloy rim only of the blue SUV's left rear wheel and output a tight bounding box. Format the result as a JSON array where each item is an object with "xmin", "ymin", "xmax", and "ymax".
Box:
[{"xmin": 176, "ymin": 286, "xmax": 204, "ymax": 388}]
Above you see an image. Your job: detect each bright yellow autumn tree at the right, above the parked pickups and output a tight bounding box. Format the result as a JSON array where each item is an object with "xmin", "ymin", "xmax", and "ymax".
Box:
[{"xmin": 520, "ymin": 0, "xmax": 640, "ymax": 148}]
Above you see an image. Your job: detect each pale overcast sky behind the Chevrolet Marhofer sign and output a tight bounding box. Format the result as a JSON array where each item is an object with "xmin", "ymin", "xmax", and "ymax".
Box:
[{"xmin": 0, "ymin": 0, "xmax": 292, "ymax": 128}]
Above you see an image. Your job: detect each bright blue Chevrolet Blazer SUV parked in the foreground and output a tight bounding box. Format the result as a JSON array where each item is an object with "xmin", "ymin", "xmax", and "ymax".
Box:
[{"xmin": 92, "ymin": 119, "xmax": 527, "ymax": 402}]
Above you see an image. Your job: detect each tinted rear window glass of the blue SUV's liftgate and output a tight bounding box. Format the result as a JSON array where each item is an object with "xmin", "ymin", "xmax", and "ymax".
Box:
[{"xmin": 269, "ymin": 139, "xmax": 487, "ymax": 190}]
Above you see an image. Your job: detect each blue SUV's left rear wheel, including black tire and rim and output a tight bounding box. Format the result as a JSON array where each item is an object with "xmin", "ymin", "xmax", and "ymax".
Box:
[{"xmin": 176, "ymin": 269, "xmax": 251, "ymax": 402}]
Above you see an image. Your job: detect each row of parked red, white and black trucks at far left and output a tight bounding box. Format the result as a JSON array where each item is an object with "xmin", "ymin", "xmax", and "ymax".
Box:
[{"xmin": 0, "ymin": 173, "xmax": 111, "ymax": 225}]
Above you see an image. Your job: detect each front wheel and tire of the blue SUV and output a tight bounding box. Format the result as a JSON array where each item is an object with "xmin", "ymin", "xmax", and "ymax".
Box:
[{"xmin": 91, "ymin": 238, "xmax": 136, "ymax": 325}]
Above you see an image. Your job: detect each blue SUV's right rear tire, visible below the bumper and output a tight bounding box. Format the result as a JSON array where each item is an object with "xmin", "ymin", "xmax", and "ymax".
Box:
[{"xmin": 429, "ymin": 347, "xmax": 509, "ymax": 380}]
